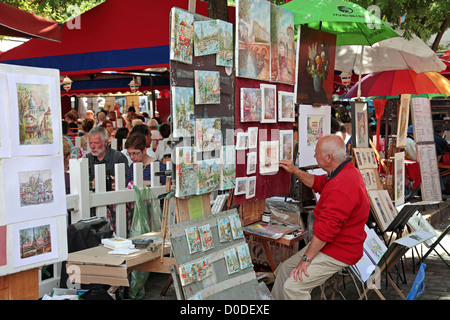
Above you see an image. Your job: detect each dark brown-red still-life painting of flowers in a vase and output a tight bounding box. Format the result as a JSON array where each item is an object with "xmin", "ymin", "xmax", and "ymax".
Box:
[{"xmin": 295, "ymin": 25, "xmax": 336, "ymax": 104}]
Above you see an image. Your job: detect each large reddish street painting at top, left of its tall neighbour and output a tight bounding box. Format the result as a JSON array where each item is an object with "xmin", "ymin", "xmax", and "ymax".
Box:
[{"xmin": 236, "ymin": 0, "xmax": 270, "ymax": 81}]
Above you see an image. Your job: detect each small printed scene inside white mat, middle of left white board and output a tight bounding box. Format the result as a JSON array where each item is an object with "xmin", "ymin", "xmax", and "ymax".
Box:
[{"xmin": 18, "ymin": 170, "xmax": 53, "ymax": 207}]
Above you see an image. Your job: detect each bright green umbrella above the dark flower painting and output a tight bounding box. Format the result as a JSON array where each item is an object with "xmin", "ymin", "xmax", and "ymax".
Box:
[{"xmin": 281, "ymin": 0, "xmax": 400, "ymax": 46}]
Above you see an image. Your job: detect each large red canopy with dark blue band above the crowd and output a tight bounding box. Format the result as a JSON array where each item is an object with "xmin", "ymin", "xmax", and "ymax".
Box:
[{"xmin": 0, "ymin": 0, "xmax": 234, "ymax": 95}]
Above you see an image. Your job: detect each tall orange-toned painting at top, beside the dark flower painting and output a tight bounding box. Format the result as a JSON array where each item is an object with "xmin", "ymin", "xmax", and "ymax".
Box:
[{"xmin": 270, "ymin": 4, "xmax": 296, "ymax": 84}]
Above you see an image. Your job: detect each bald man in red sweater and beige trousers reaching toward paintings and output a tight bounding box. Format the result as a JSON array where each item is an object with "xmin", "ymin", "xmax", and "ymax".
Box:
[{"xmin": 272, "ymin": 135, "xmax": 370, "ymax": 300}]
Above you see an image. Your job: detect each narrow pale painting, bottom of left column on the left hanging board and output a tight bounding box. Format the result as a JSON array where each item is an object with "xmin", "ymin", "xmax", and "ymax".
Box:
[{"xmin": 175, "ymin": 147, "xmax": 197, "ymax": 197}]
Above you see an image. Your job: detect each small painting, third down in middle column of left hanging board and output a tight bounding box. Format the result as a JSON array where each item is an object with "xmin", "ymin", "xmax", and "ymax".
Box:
[{"xmin": 195, "ymin": 118, "xmax": 222, "ymax": 152}]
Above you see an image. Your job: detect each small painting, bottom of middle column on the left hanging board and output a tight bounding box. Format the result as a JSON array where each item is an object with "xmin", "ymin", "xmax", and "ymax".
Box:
[{"xmin": 197, "ymin": 158, "xmax": 221, "ymax": 194}]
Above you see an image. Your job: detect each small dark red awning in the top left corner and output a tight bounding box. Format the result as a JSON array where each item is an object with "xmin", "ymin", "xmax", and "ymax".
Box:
[{"xmin": 0, "ymin": 2, "xmax": 63, "ymax": 42}]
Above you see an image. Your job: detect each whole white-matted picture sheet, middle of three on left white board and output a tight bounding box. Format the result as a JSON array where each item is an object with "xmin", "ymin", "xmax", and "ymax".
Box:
[{"xmin": 0, "ymin": 156, "xmax": 67, "ymax": 224}]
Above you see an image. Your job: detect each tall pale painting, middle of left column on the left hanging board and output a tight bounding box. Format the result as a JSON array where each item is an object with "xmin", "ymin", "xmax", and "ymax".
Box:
[{"xmin": 171, "ymin": 87, "xmax": 195, "ymax": 138}]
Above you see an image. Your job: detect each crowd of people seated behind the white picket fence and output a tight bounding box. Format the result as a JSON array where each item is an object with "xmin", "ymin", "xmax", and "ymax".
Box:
[{"xmin": 62, "ymin": 106, "xmax": 171, "ymax": 193}]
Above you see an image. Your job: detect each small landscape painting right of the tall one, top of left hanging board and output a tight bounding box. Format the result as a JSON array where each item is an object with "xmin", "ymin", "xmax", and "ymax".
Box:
[{"xmin": 194, "ymin": 20, "xmax": 219, "ymax": 57}]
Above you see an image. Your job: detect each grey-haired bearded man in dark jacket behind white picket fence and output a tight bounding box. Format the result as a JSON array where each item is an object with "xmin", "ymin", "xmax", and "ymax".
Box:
[{"xmin": 84, "ymin": 126, "xmax": 129, "ymax": 186}]
